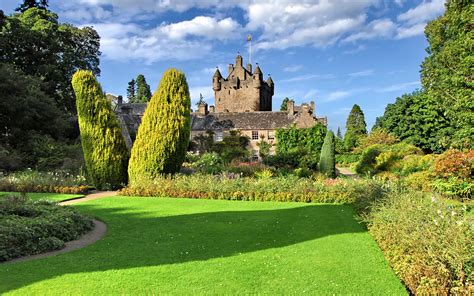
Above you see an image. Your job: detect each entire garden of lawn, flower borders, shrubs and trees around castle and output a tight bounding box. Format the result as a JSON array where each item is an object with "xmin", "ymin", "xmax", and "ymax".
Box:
[{"xmin": 0, "ymin": 1, "xmax": 474, "ymax": 295}]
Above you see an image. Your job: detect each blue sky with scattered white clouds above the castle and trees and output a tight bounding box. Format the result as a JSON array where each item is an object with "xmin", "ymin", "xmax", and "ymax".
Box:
[{"xmin": 0, "ymin": 0, "xmax": 444, "ymax": 131}]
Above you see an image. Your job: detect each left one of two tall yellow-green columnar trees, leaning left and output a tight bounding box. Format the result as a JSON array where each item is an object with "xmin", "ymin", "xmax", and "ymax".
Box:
[{"xmin": 72, "ymin": 70, "xmax": 129, "ymax": 190}]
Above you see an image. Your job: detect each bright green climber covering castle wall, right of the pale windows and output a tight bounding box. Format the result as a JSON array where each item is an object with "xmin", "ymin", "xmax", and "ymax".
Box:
[{"xmin": 276, "ymin": 124, "xmax": 326, "ymax": 154}]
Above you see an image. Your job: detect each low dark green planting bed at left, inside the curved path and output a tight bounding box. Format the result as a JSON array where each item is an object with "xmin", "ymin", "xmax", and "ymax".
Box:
[{"xmin": 0, "ymin": 196, "xmax": 93, "ymax": 261}]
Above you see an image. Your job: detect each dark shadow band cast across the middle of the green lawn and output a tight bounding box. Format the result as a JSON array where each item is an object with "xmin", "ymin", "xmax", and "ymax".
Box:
[{"xmin": 0, "ymin": 204, "xmax": 365, "ymax": 294}]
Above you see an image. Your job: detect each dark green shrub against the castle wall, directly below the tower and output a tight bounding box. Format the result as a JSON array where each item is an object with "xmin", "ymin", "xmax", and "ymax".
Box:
[{"xmin": 211, "ymin": 131, "xmax": 250, "ymax": 164}]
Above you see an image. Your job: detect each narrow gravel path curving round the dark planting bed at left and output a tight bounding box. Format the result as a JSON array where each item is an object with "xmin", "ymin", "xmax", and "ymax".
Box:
[{"xmin": 0, "ymin": 191, "xmax": 117, "ymax": 264}]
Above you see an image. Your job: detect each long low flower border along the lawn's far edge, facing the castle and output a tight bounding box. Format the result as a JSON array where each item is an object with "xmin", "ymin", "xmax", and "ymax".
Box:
[{"xmin": 119, "ymin": 174, "xmax": 382, "ymax": 203}]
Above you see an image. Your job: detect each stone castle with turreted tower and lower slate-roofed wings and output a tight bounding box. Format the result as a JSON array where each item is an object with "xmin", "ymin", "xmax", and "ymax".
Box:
[{"xmin": 116, "ymin": 55, "xmax": 327, "ymax": 160}]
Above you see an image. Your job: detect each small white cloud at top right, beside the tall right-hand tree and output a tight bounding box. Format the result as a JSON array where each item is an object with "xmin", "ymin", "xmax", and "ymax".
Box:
[{"xmin": 397, "ymin": 0, "xmax": 445, "ymax": 25}]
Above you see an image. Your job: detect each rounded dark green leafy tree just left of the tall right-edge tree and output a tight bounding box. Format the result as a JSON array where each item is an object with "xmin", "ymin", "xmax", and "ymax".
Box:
[{"xmin": 374, "ymin": 91, "xmax": 453, "ymax": 152}]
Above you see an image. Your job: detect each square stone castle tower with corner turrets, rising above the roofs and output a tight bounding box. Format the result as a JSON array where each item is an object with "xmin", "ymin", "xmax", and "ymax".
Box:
[{"xmin": 212, "ymin": 54, "xmax": 274, "ymax": 112}]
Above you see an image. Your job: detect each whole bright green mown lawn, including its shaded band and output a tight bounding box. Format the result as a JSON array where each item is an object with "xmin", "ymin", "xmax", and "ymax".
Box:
[{"xmin": 0, "ymin": 197, "xmax": 406, "ymax": 295}]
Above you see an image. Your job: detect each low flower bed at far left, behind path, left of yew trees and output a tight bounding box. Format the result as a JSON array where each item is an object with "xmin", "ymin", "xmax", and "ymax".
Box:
[{"xmin": 0, "ymin": 170, "xmax": 89, "ymax": 194}]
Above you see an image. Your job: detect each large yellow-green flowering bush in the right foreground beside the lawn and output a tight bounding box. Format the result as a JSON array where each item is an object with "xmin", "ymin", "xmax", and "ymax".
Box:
[{"xmin": 364, "ymin": 192, "xmax": 474, "ymax": 295}]
